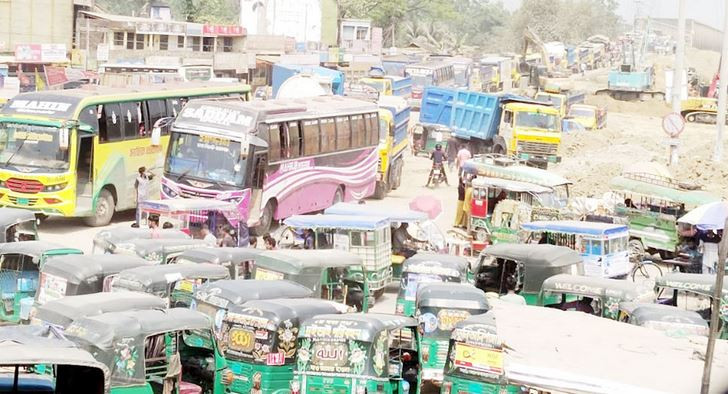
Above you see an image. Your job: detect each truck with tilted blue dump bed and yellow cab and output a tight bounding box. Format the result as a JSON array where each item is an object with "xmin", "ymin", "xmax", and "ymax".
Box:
[{"xmin": 420, "ymin": 87, "xmax": 561, "ymax": 168}]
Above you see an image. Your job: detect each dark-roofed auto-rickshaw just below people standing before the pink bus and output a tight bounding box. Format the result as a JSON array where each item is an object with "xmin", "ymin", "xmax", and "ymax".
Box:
[{"xmin": 176, "ymin": 247, "xmax": 265, "ymax": 279}]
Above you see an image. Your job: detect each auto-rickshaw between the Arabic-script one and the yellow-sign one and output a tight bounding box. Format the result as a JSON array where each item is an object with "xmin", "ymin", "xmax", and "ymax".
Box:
[{"xmin": 415, "ymin": 283, "xmax": 490, "ymax": 386}]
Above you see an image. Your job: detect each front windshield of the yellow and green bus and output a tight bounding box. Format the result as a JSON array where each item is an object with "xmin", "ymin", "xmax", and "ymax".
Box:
[{"xmin": 0, "ymin": 123, "xmax": 68, "ymax": 171}]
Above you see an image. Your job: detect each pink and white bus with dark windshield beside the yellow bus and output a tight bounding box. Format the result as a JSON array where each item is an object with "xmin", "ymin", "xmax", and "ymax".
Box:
[{"xmin": 162, "ymin": 96, "xmax": 386, "ymax": 235}]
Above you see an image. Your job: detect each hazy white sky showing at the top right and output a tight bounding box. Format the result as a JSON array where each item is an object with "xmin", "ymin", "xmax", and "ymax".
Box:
[{"xmin": 501, "ymin": 0, "xmax": 725, "ymax": 30}]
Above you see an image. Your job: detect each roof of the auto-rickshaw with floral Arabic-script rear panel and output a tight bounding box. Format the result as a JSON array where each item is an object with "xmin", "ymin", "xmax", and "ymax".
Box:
[{"xmin": 298, "ymin": 313, "xmax": 417, "ymax": 342}]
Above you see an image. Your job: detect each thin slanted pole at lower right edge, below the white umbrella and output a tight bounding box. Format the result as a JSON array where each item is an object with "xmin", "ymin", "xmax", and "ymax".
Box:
[{"xmin": 700, "ymin": 217, "xmax": 728, "ymax": 394}]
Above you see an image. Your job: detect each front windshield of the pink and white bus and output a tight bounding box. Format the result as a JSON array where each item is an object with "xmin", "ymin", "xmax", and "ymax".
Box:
[{"xmin": 165, "ymin": 131, "xmax": 246, "ymax": 186}]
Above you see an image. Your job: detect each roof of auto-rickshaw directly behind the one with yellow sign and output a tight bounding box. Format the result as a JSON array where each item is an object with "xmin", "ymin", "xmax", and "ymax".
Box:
[{"xmin": 416, "ymin": 282, "xmax": 490, "ymax": 309}]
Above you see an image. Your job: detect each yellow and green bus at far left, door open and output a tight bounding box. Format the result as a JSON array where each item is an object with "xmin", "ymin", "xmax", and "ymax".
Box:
[{"xmin": 0, "ymin": 83, "xmax": 250, "ymax": 226}]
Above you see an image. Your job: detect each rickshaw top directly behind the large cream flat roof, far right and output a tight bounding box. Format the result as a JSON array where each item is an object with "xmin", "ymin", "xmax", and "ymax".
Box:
[{"xmin": 619, "ymin": 303, "xmax": 710, "ymax": 337}]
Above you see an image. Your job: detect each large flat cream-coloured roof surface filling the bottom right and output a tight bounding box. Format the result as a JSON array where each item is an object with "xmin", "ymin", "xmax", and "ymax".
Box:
[{"xmin": 452, "ymin": 303, "xmax": 728, "ymax": 393}]
